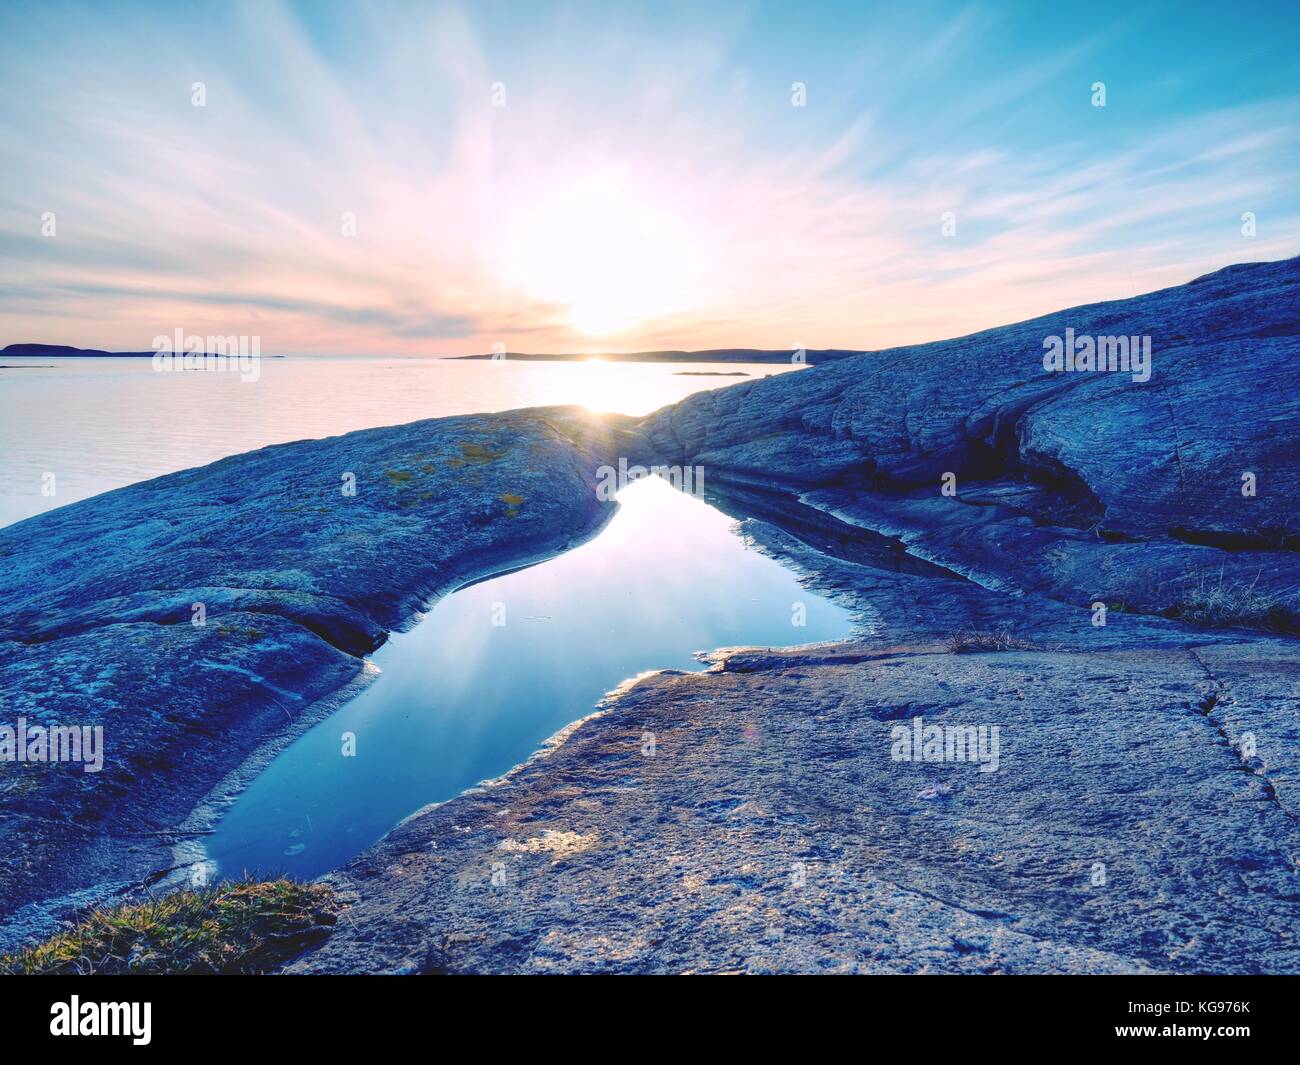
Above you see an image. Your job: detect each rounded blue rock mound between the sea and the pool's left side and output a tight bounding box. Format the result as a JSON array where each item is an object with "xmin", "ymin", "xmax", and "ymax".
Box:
[{"xmin": 0, "ymin": 408, "xmax": 627, "ymax": 940}]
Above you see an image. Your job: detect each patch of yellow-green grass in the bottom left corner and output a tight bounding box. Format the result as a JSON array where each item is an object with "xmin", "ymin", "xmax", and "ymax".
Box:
[{"xmin": 0, "ymin": 879, "xmax": 334, "ymax": 975}]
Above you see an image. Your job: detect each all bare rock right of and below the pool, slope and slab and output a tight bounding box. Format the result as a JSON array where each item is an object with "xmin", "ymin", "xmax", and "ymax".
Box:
[{"xmin": 291, "ymin": 260, "xmax": 1300, "ymax": 973}]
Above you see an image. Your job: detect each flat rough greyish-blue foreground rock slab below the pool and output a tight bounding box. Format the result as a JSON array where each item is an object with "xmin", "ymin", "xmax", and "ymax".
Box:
[{"xmin": 291, "ymin": 642, "xmax": 1300, "ymax": 973}]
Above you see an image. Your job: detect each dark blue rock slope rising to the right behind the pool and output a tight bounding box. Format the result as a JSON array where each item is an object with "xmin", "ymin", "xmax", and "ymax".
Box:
[{"xmin": 644, "ymin": 259, "xmax": 1300, "ymax": 631}]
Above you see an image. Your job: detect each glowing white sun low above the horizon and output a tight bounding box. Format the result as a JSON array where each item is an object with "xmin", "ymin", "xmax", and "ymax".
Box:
[{"xmin": 507, "ymin": 170, "xmax": 701, "ymax": 337}]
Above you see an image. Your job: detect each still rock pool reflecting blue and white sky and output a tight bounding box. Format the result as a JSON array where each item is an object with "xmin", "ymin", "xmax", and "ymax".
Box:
[{"xmin": 209, "ymin": 479, "xmax": 850, "ymax": 876}]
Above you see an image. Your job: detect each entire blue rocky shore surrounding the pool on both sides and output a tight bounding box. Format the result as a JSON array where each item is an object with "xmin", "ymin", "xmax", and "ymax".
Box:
[{"xmin": 0, "ymin": 260, "xmax": 1300, "ymax": 973}]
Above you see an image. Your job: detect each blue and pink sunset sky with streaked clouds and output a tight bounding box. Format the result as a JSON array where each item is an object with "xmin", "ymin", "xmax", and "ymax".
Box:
[{"xmin": 0, "ymin": 0, "xmax": 1300, "ymax": 355}]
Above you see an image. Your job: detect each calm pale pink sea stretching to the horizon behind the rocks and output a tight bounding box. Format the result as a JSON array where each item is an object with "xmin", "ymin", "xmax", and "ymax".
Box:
[{"xmin": 0, "ymin": 356, "xmax": 796, "ymax": 525}]
